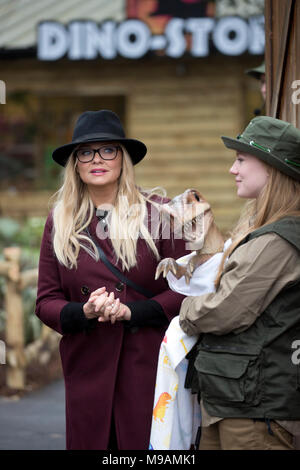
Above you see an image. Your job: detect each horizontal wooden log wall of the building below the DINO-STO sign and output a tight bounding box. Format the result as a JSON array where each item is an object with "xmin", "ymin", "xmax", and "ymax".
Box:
[{"xmin": 0, "ymin": 57, "xmax": 261, "ymax": 232}]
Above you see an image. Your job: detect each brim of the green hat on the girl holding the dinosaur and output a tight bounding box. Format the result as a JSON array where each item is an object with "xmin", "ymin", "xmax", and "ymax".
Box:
[{"xmin": 222, "ymin": 136, "xmax": 300, "ymax": 181}]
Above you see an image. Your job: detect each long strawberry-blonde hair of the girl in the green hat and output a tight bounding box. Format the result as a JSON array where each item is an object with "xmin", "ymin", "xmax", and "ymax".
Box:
[{"xmin": 215, "ymin": 165, "xmax": 300, "ymax": 287}]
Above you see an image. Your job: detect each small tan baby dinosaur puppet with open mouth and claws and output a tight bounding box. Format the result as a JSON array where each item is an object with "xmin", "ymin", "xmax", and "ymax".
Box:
[{"xmin": 155, "ymin": 189, "xmax": 224, "ymax": 284}]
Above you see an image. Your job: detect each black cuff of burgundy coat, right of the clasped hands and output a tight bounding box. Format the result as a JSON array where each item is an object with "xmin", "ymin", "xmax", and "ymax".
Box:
[{"xmin": 124, "ymin": 299, "xmax": 169, "ymax": 328}]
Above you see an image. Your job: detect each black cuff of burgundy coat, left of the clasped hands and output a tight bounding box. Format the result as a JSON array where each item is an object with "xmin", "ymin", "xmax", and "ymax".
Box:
[{"xmin": 60, "ymin": 302, "xmax": 97, "ymax": 334}]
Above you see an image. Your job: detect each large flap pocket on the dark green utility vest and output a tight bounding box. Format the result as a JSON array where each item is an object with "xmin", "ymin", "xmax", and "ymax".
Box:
[{"xmin": 195, "ymin": 350, "xmax": 261, "ymax": 406}]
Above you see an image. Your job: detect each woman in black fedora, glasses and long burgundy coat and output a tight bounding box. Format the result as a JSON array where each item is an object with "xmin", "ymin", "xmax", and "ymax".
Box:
[{"xmin": 36, "ymin": 110, "xmax": 189, "ymax": 450}]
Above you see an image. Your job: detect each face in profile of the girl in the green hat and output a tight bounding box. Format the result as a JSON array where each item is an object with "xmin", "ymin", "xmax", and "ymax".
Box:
[{"xmin": 229, "ymin": 152, "xmax": 269, "ymax": 199}]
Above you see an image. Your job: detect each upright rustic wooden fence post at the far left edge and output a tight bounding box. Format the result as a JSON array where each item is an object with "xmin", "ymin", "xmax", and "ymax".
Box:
[{"xmin": 3, "ymin": 247, "xmax": 26, "ymax": 389}]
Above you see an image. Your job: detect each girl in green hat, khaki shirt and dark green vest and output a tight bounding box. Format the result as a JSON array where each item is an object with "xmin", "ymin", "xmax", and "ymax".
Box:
[{"xmin": 173, "ymin": 116, "xmax": 300, "ymax": 450}]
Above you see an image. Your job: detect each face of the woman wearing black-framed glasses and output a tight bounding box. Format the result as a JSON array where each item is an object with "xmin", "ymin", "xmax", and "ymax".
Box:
[{"xmin": 74, "ymin": 142, "xmax": 122, "ymax": 187}]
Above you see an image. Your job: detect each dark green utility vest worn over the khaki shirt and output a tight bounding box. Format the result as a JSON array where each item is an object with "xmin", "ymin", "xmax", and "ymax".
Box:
[{"xmin": 195, "ymin": 218, "xmax": 300, "ymax": 420}]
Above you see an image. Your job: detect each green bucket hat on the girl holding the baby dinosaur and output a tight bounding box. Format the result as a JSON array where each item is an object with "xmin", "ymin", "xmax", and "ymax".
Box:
[{"xmin": 222, "ymin": 116, "xmax": 300, "ymax": 181}]
